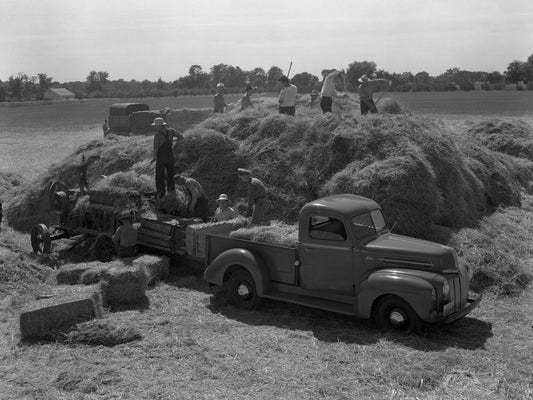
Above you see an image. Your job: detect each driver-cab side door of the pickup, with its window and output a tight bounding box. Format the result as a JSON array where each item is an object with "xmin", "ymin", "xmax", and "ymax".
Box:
[{"xmin": 300, "ymin": 214, "xmax": 354, "ymax": 296}]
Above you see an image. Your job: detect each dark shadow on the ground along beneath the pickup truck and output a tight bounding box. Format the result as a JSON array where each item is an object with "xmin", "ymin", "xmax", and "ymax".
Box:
[{"xmin": 207, "ymin": 294, "xmax": 492, "ymax": 351}]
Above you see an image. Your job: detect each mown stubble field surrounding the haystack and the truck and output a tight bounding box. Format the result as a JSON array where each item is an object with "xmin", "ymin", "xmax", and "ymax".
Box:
[{"xmin": 0, "ymin": 92, "xmax": 533, "ymax": 400}]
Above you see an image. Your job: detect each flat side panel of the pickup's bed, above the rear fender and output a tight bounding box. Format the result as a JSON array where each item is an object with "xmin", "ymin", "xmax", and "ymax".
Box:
[{"xmin": 206, "ymin": 234, "xmax": 298, "ymax": 285}]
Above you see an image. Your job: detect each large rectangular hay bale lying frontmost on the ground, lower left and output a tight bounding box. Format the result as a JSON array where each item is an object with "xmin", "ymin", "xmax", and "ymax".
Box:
[{"xmin": 20, "ymin": 285, "xmax": 103, "ymax": 341}]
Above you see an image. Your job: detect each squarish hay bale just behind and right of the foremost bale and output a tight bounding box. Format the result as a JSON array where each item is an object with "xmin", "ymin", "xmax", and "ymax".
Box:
[{"xmin": 100, "ymin": 267, "xmax": 148, "ymax": 309}]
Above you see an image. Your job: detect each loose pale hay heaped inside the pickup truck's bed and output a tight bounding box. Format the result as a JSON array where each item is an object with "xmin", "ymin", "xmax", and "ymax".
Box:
[{"xmin": 229, "ymin": 221, "xmax": 298, "ymax": 247}]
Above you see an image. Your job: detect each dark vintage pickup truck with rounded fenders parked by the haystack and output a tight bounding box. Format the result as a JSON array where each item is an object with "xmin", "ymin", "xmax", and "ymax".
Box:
[{"xmin": 204, "ymin": 194, "xmax": 481, "ymax": 333}]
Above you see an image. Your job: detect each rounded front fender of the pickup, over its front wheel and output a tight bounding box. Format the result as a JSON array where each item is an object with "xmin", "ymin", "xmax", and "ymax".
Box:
[{"xmin": 357, "ymin": 269, "xmax": 437, "ymax": 322}]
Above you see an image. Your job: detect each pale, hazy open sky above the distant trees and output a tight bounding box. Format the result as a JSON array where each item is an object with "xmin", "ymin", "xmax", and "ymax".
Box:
[{"xmin": 0, "ymin": 0, "xmax": 533, "ymax": 82}]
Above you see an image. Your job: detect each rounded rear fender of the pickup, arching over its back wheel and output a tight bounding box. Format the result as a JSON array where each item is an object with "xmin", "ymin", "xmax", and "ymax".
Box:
[{"xmin": 204, "ymin": 248, "xmax": 271, "ymax": 296}]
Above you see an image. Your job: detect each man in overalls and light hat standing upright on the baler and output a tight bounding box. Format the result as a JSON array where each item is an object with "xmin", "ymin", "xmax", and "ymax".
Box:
[{"xmin": 152, "ymin": 117, "xmax": 177, "ymax": 199}]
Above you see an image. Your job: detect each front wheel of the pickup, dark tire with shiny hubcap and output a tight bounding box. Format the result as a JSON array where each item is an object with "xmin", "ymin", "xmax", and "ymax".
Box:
[{"xmin": 375, "ymin": 296, "xmax": 422, "ymax": 334}]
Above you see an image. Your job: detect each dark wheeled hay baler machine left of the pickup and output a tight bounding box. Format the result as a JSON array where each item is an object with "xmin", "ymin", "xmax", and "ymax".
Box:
[{"xmin": 31, "ymin": 181, "xmax": 201, "ymax": 261}]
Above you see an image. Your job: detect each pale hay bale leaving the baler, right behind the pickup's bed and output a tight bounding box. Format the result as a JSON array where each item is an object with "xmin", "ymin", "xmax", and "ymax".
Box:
[{"xmin": 185, "ymin": 217, "xmax": 247, "ymax": 257}]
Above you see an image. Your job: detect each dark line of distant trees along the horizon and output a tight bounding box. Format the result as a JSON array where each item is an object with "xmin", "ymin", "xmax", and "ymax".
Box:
[{"xmin": 0, "ymin": 54, "xmax": 533, "ymax": 102}]
